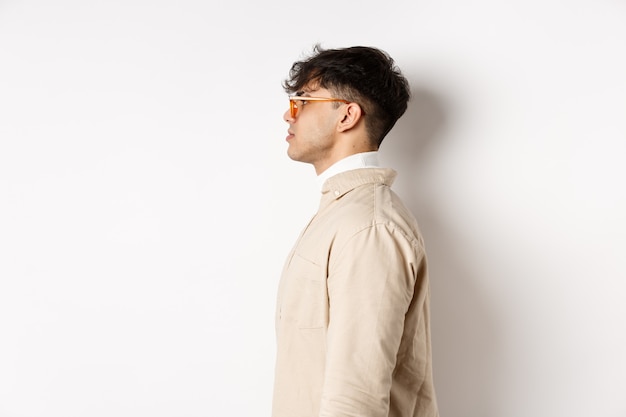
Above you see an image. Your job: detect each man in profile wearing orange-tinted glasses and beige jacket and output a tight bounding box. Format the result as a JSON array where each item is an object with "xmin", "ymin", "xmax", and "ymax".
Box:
[{"xmin": 273, "ymin": 46, "xmax": 438, "ymax": 417}]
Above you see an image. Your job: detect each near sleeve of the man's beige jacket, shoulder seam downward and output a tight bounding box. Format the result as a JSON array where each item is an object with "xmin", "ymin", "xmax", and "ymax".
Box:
[{"xmin": 320, "ymin": 223, "xmax": 423, "ymax": 417}]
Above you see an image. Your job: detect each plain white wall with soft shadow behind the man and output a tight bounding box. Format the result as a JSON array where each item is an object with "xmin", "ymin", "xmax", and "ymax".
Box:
[{"xmin": 0, "ymin": 0, "xmax": 626, "ymax": 417}]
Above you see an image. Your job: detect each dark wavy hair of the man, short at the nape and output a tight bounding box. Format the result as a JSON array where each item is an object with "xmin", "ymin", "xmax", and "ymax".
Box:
[{"xmin": 283, "ymin": 44, "xmax": 411, "ymax": 147}]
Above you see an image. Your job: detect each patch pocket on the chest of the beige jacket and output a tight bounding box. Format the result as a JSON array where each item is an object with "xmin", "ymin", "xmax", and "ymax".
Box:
[{"xmin": 282, "ymin": 253, "xmax": 328, "ymax": 329}]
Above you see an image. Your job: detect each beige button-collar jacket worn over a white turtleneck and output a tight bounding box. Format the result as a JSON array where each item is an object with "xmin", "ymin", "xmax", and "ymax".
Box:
[{"xmin": 272, "ymin": 168, "xmax": 438, "ymax": 417}]
